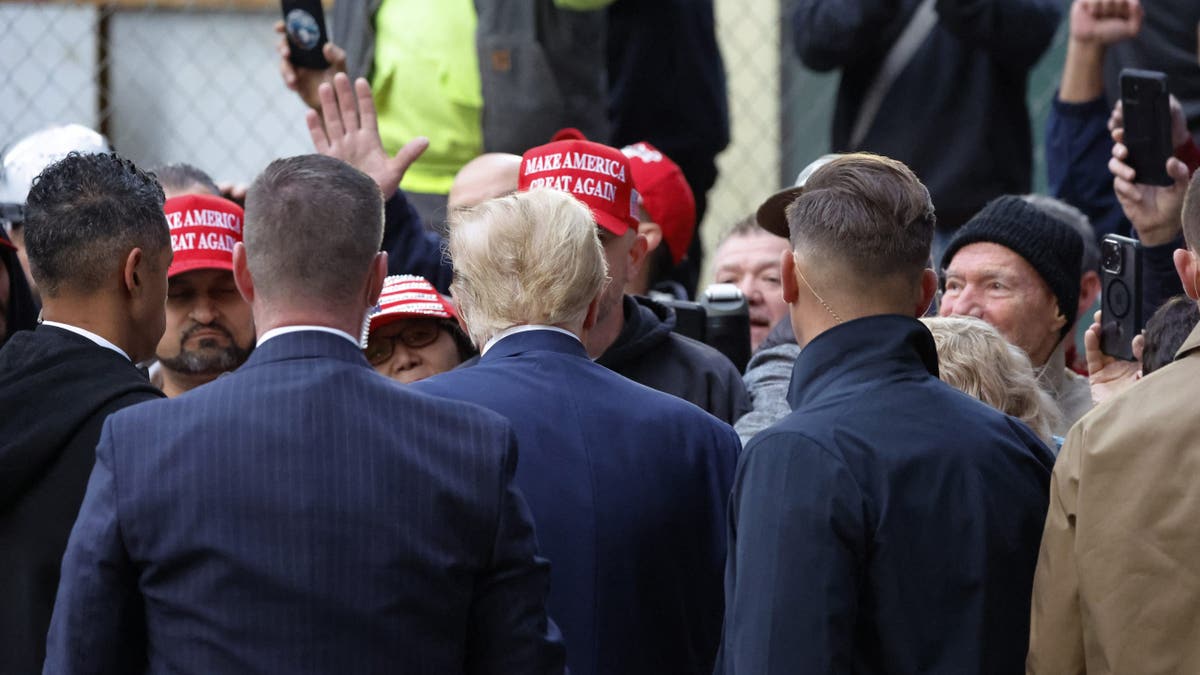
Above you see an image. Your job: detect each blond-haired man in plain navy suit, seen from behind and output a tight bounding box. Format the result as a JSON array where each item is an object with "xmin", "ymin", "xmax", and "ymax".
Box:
[{"xmin": 413, "ymin": 189, "xmax": 739, "ymax": 675}]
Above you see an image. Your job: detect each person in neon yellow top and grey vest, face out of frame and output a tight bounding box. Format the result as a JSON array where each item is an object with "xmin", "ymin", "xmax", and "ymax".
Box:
[{"xmin": 276, "ymin": 0, "xmax": 613, "ymax": 226}]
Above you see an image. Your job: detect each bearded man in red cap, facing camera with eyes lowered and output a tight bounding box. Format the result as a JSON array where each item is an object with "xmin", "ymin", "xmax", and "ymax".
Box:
[{"xmin": 156, "ymin": 195, "xmax": 254, "ymax": 398}]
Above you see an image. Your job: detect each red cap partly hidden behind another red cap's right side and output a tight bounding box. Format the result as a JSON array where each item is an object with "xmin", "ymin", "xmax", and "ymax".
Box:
[{"xmin": 620, "ymin": 142, "xmax": 696, "ymax": 264}]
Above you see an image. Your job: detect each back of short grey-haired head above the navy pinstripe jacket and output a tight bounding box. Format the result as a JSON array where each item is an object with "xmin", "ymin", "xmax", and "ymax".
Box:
[{"xmin": 244, "ymin": 155, "xmax": 383, "ymax": 309}]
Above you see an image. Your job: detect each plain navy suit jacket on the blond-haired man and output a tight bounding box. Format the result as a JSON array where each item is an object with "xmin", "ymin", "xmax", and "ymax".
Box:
[{"xmin": 414, "ymin": 330, "xmax": 740, "ymax": 675}]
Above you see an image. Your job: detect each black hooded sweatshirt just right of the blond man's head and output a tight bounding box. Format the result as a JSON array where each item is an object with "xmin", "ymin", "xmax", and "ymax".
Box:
[{"xmin": 596, "ymin": 295, "xmax": 750, "ymax": 424}]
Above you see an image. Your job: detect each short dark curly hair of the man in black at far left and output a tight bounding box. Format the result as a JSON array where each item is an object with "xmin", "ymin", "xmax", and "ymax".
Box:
[{"xmin": 25, "ymin": 153, "xmax": 170, "ymax": 297}]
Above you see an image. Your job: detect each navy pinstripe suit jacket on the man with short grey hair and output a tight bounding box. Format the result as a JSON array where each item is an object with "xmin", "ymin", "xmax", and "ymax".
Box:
[{"xmin": 44, "ymin": 330, "xmax": 564, "ymax": 675}]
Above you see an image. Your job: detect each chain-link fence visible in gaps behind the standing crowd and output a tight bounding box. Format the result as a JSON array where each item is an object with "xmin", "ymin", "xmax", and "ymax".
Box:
[{"xmin": 0, "ymin": 0, "xmax": 1064, "ymax": 267}]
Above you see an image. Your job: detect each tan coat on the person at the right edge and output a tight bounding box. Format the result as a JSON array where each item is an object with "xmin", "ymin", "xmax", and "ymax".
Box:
[{"xmin": 1026, "ymin": 327, "xmax": 1200, "ymax": 675}]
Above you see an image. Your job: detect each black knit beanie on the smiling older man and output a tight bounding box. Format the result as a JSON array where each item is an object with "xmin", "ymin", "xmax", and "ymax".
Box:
[{"xmin": 942, "ymin": 195, "xmax": 1084, "ymax": 335}]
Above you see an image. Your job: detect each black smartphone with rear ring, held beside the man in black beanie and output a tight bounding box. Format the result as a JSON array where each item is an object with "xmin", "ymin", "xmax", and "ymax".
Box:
[{"xmin": 1100, "ymin": 234, "xmax": 1142, "ymax": 362}]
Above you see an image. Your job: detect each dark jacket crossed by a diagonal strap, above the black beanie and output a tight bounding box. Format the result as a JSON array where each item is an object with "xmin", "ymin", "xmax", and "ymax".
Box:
[{"xmin": 792, "ymin": 0, "xmax": 1062, "ymax": 228}]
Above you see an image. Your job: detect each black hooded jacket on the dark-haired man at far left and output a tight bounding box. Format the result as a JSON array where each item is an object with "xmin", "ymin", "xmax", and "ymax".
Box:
[{"xmin": 0, "ymin": 325, "xmax": 162, "ymax": 675}]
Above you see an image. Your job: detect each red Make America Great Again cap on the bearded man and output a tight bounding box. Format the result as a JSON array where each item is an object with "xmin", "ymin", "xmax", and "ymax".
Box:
[{"xmin": 162, "ymin": 195, "xmax": 244, "ymax": 277}]
